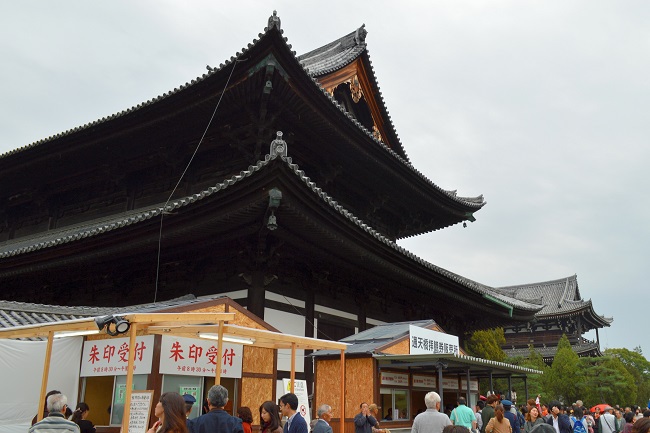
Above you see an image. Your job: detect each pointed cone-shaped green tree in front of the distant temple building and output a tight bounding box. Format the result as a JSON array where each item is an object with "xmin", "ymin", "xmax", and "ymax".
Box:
[{"xmin": 543, "ymin": 335, "xmax": 584, "ymax": 403}]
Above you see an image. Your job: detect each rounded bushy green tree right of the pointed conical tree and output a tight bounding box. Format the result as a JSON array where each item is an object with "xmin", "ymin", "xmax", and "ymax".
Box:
[{"xmin": 580, "ymin": 355, "xmax": 637, "ymax": 406}]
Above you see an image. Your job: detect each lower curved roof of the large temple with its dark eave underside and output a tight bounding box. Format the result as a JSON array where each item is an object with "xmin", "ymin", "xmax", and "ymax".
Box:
[{"xmin": 0, "ymin": 155, "xmax": 541, "ymax": 323}]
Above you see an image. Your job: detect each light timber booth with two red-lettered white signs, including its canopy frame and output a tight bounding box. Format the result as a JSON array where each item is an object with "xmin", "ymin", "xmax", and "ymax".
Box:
[{"xmin": 0, "ymin": 298, "xmax": 347, "ymax": 433}]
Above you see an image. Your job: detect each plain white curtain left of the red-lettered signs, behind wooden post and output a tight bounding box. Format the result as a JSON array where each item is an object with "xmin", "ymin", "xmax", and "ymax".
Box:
[{"xmin": 0, "ymin": 337, "xmax": 83, "ymax": 433}]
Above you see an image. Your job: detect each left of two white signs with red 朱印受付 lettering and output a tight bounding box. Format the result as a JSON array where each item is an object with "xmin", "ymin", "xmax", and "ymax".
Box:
[{"xmin": 80, "ymin": 335, "xmax": 153, "ymax": 377}]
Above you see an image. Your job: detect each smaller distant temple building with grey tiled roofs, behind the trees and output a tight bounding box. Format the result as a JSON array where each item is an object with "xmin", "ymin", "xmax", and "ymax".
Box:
[{"xmin": 501, "ymin": 275, "xmax": 613, "ymax": 364}]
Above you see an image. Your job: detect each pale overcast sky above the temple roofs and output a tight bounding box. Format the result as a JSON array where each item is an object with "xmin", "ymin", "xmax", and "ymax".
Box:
[{"xmin": 0, "ymin": 0, "xmax": 650, "ymax": 358}]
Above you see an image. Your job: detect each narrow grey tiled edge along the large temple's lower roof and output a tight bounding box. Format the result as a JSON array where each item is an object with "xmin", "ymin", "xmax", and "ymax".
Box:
[{"xmin": 0, "ymin": 155, "xmax": 540, "ymax": 311}]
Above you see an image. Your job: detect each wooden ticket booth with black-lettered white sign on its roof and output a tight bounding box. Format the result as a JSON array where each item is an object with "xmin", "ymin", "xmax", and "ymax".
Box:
[{"xmin": 314, "ymin": 320, "xmax": 541, "ymax": 433}]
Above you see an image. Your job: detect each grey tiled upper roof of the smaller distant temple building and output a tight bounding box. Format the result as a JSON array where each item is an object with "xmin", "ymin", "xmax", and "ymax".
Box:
[{"xmin": 498, "ymin": 275, "xmax": 613, "ymax": 329}]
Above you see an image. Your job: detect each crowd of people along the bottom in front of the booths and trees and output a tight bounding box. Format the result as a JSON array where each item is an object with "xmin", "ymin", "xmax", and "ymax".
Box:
[{"xmin": 29, "ymin": 385, "xmax": 650, "ymax": 433}]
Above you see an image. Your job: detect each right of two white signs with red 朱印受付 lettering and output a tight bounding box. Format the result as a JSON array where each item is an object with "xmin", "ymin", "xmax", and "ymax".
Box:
[{"xmin": 160, "ymin": 335, "xmax": 244, "ymax": 378}]
